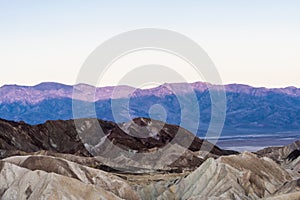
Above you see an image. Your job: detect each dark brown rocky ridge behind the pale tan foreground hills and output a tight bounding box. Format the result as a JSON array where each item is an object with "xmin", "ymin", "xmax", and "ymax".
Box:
[{"xmin": 0, "ymin": 118, "xmax": 237, "ymax": 173}]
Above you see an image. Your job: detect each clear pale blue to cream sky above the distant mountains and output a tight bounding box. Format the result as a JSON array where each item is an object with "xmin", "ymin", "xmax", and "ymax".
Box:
[{"xmin": 0, "ymin": 0, "xmax": 300, "ymax": 87}]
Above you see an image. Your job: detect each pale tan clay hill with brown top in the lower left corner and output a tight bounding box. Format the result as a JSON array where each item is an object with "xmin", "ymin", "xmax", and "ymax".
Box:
[{"xmin": 0, "ymin": 156, "xmax": 139, "ymax": 200}]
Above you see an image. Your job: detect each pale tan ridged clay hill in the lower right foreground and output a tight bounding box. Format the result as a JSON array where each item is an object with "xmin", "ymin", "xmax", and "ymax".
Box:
[{"xmin": 158, "ymin": 153, "xmax": 300, "ymax": 200}]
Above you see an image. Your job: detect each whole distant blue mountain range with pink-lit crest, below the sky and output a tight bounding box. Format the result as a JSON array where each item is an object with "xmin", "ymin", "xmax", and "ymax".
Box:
[{"xmin": 0, "ymin": 82, "xmax": 300, "ymax": 136}]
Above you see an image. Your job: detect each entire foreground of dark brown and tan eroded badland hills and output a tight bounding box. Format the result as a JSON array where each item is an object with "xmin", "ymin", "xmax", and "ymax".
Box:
[{"xmin": 0, "ymin": 118, "xmax": 300, "ymax": 200}]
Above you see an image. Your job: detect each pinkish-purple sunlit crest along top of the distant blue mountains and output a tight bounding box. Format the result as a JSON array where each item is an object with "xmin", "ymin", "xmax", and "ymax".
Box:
[{"xmin": 0, "ymin": 82, "xmax": 300, "ymax": 105}]
